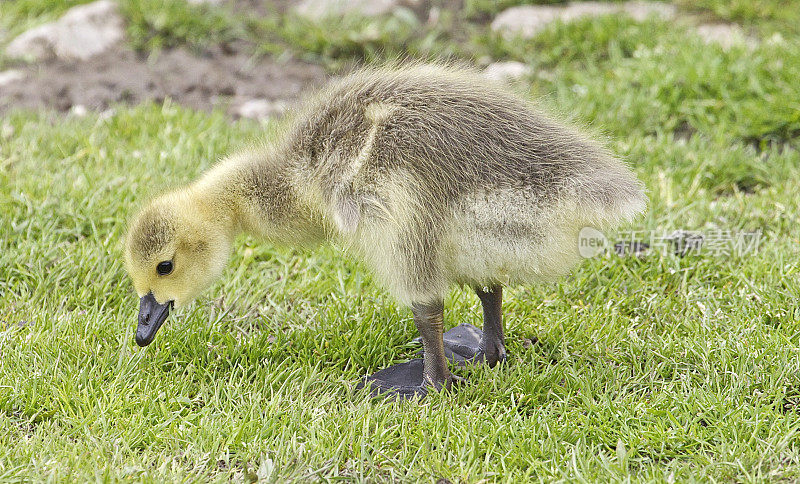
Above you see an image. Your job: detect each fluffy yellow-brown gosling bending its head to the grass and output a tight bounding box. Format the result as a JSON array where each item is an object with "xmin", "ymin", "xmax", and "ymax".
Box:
[{"xmin": 125, "ymin": 65, "xmax": 646, "ymax": 395}]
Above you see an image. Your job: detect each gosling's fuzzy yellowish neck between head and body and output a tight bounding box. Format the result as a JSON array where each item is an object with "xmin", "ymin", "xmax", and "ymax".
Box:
[{"xmin": 192, "ymin": 150, "xmax": 325, "ymax": 246}]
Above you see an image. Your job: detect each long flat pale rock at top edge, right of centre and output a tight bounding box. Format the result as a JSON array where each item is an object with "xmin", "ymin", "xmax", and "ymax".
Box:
[{"xmin": 491, "ymin": 2, "xmax": 675, "ymax": 38}]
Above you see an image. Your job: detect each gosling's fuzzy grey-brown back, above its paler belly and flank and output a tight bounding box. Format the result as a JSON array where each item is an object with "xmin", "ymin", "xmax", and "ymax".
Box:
[{"xmin": 288, "ymin": 65, "xmax": 641, "ymax": 203}]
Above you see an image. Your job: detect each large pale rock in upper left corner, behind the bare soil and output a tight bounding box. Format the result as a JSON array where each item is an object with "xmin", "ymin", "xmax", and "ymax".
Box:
[{"xmin": 6, "ymin": 0, "xmax": 124, "ymax": 60}]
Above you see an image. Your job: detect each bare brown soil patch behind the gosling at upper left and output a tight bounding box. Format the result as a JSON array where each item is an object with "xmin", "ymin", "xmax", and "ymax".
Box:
[{"xmin": 0, "ymin": 43, "xmax": 326, "ymax": 116}]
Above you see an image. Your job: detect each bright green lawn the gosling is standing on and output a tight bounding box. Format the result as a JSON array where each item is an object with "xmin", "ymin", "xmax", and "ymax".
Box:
[{"xmin": 0, "ymin": 0, "xmax": 800, "ymax": 483}]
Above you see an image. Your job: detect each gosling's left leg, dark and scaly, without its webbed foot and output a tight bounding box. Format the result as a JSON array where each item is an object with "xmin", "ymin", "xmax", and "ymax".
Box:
[{"xmin": 411, "ymin": 301, "xmax": 452, "ymax": 390}]
